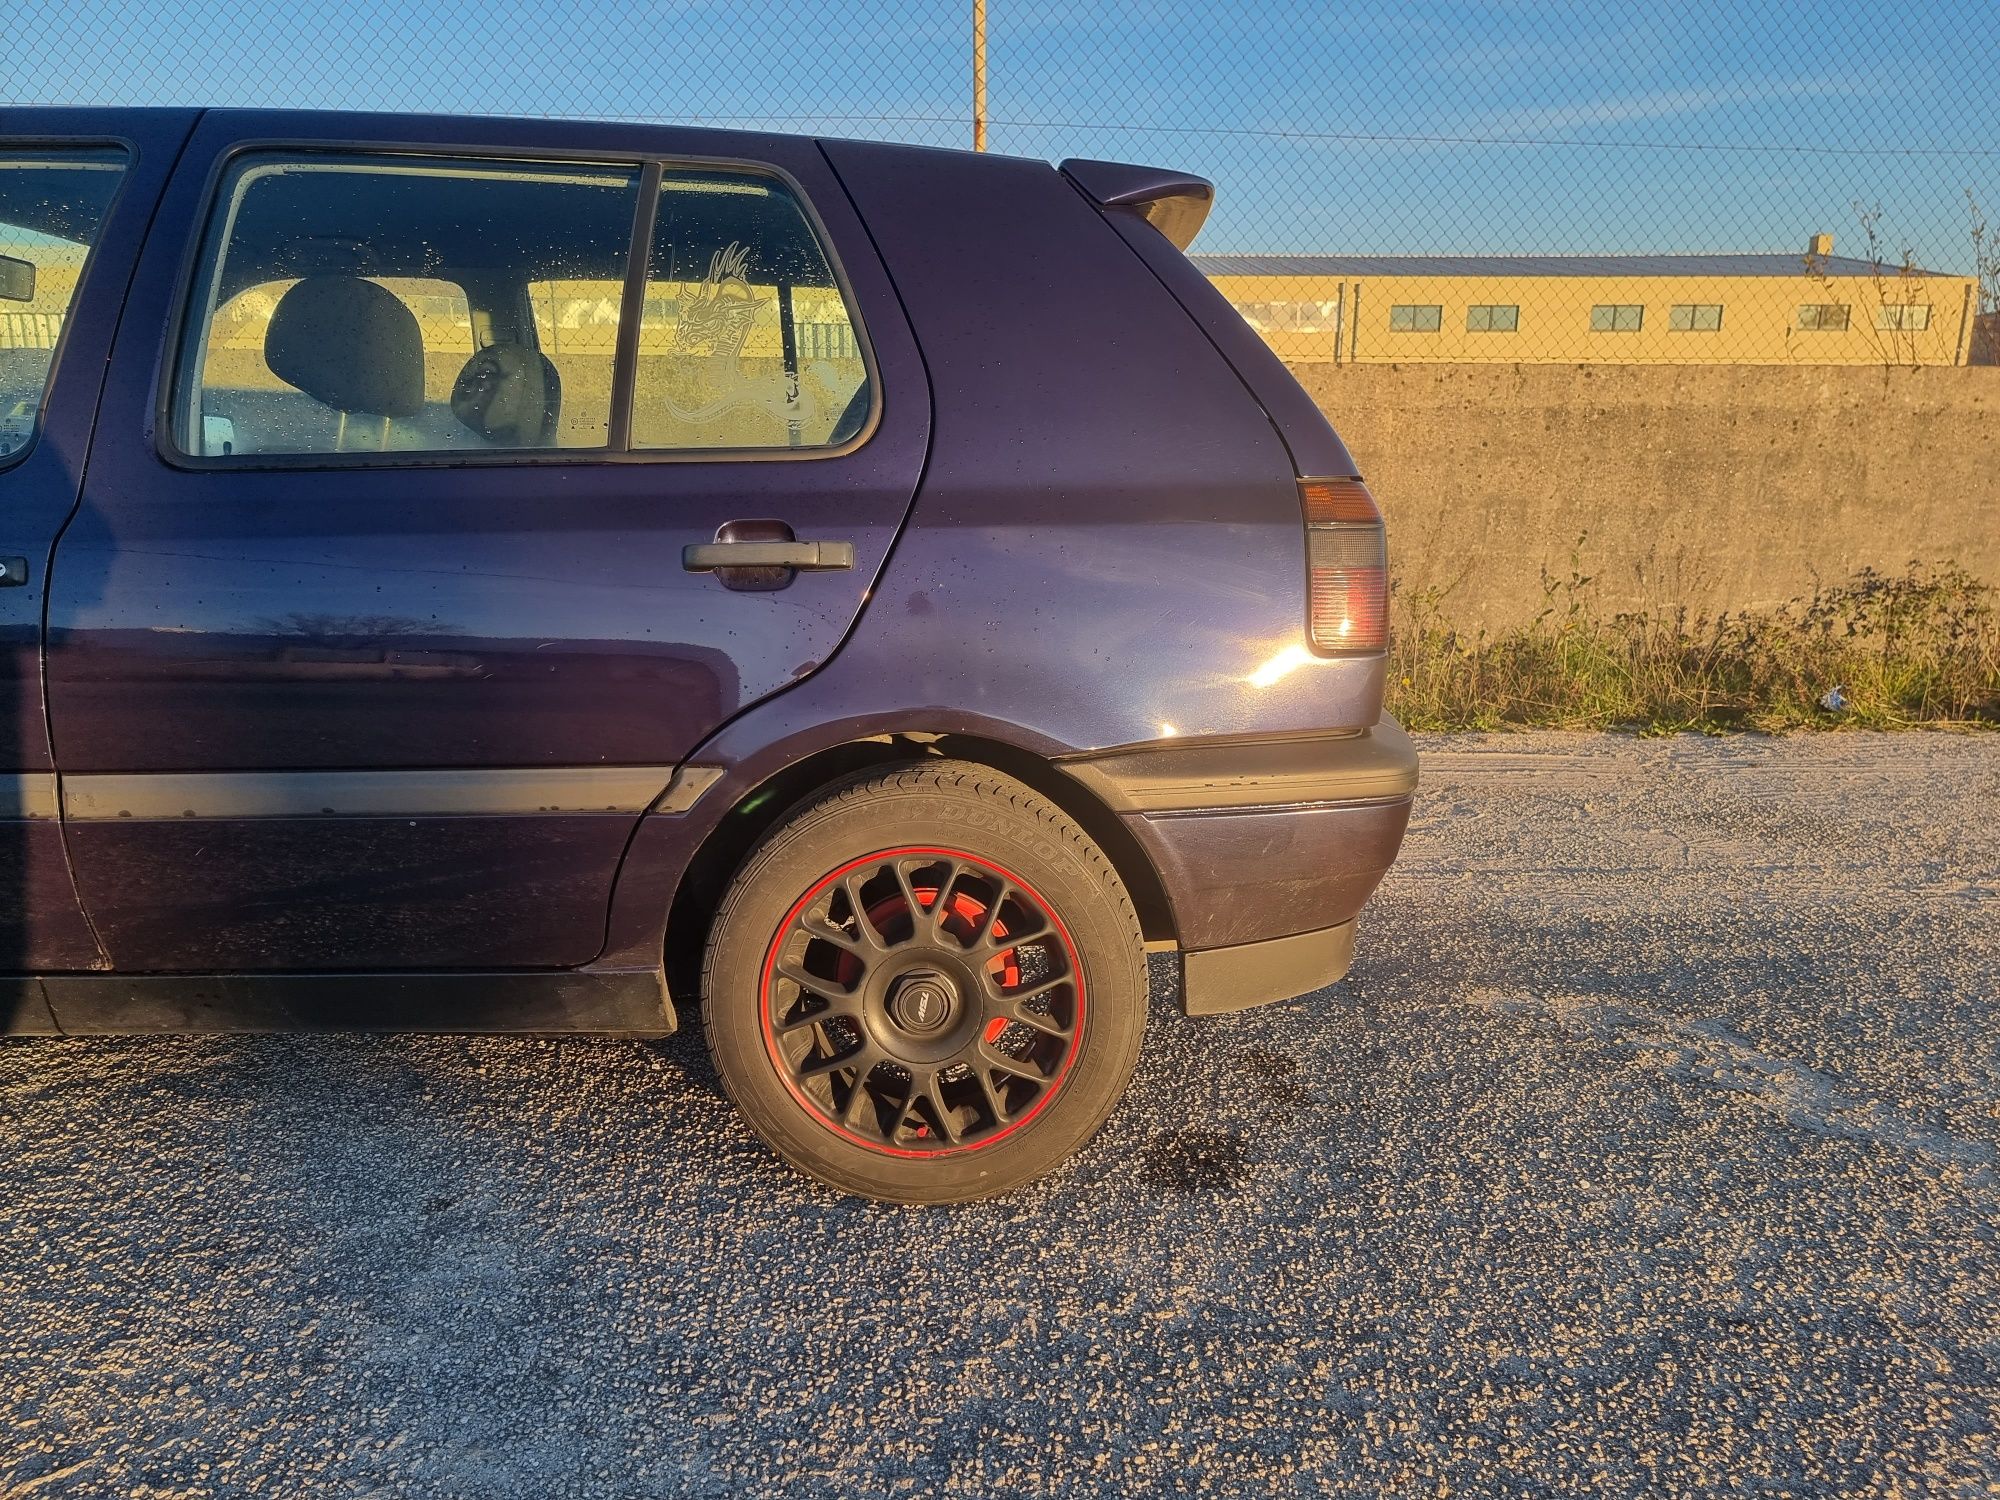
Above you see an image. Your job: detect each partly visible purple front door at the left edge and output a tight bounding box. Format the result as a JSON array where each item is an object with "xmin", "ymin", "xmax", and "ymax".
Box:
[{"xmin": 0, "ymin": 110, "xmax": 194, "ymax": 992}]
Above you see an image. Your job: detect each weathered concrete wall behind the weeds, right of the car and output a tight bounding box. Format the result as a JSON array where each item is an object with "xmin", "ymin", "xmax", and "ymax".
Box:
[{"xmin": 1294, "ymin": 364, "xmax": 2000, "ymax": 628}]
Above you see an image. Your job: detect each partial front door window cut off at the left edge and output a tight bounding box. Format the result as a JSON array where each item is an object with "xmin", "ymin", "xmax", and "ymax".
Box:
[{"xmin": 0, "ymin": 150, "xmax": 124, "ymax": 464}]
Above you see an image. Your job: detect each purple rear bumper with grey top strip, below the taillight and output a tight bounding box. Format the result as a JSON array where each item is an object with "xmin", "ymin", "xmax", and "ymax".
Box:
[{"xmin": 1064, "ymin": 718, "xmax": 1416, "ymax": 1014}]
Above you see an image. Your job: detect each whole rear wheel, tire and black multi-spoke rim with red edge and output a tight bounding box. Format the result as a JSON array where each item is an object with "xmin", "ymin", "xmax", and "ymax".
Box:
[{"xmin": 702, "ymin": 760, "xmax": 1146, "ymax": 1204}]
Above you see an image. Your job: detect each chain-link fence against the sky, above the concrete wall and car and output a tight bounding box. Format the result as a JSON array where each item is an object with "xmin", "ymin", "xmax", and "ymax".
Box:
[{"xmin": 0, "ymin": 0, "xmax": 2000, "ymax": 366}]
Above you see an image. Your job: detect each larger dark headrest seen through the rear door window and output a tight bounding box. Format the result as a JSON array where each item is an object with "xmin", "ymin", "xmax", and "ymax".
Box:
[{"xmin": 264, "ymin": 276, "xmax": 424, "ymax": 416}]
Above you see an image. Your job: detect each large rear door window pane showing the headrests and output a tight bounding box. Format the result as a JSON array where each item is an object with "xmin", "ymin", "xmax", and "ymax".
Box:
[{"xmin": 172, "ymin": 156, "xmax": 640, "ymax": 458}]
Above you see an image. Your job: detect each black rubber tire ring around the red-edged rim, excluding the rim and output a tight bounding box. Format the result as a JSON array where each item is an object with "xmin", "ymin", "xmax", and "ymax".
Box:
[{"xmin": 704, "ymin": 778, "xmax": 1146, "ymax": 1202}]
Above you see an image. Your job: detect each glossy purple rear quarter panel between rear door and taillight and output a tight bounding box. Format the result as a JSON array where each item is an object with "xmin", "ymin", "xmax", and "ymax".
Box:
[{"xmin": 604, "ymin": 142, "xmax": 1382, "ymax": 976}]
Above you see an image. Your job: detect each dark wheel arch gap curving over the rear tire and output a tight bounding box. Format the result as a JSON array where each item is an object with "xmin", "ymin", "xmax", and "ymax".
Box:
[{"xmin": 666, "ymin": 730, "xmax": 1176, "ymax": 1012}]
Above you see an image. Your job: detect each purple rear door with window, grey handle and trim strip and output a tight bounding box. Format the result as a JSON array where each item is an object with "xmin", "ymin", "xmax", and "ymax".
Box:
[{"xmin": 48, "ymin": 112, "xmax": 930, "ymax": 970}]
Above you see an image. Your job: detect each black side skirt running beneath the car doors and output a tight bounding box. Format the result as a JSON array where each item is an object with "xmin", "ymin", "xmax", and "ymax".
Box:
[{"xmin": 0, "ymin": 968, "xmax": 680, "ymax": 1036}]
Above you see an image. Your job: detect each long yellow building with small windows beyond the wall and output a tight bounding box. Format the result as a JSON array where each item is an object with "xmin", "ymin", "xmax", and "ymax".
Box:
[{"xmin": 1194, "ymin": 234, "xmax": 1978, "ymax": 366}]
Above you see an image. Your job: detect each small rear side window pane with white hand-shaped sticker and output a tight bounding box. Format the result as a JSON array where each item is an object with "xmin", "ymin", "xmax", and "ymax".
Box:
[{"xmin": 632, "ymin": 168, "xmax": 872, "ymax": 450}]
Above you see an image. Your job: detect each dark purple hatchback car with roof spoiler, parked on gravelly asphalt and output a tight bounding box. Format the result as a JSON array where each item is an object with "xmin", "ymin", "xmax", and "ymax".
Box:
[{"xmin": 0, "ymin": 110, "xmax": 1416, "ymax": 1202}]
